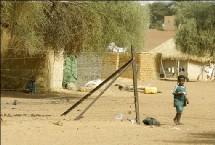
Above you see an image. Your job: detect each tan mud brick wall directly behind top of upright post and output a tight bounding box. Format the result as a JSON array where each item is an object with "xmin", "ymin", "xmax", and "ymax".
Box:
[{"xmin": 105, "ymin": 53, "xmax": 161, "ymax": 81}]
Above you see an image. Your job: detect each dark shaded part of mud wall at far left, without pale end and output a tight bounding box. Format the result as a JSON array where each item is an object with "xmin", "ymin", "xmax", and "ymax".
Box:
[{"xmin": 1, "ymin": 51, "xmax": 47, "ymax": 91}]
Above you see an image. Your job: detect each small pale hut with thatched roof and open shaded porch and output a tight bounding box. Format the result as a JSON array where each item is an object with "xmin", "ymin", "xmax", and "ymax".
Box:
[{"xmin": 150, "ymin": 38, "xmax": 214, "ymax": 80}]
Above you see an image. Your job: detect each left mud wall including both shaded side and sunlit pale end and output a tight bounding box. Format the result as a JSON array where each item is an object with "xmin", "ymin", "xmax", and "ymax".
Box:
[{"xmin": 1, "ymin": 49, "xmax": 64, "ymax": 92}]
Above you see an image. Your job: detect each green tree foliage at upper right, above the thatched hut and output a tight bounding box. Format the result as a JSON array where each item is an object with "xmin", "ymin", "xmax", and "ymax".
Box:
[{"xmin": 176, "ymin": 2, "xmax": 215, "ymax": 56}]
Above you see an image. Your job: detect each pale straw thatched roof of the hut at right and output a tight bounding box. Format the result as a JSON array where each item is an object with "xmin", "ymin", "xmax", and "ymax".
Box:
[{"xmin": 150, "ymin": 38, "xmax": 214, "ymax": 62}]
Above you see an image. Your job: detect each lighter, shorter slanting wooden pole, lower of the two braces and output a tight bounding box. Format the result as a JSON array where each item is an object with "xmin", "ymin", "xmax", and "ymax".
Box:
[{"xmin": 74, "ymin": 61, "xmax": 132, "ymax": 120}]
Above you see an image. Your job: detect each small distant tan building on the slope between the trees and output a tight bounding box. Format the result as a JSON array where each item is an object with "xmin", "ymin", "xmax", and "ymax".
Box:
[{"xmin": 164, "ymin": 16, "xmax": 176, "ymax": 31}]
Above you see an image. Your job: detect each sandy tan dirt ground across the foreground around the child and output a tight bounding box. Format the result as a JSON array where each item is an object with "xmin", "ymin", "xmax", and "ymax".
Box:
[{"xmin": 1, "ymin": 78, "xmax": 215, "ymax": 145}]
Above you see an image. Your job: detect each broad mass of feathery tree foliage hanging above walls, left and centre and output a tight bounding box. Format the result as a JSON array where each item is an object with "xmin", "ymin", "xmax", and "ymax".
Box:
[{"xmin": 3, "ymin": 1, "xmax": 149, "ymax": 54}]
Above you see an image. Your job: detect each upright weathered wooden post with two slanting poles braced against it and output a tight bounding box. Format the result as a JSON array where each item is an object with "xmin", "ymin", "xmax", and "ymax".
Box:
[{"xmin": 131, "ymin": 46, "xmax": 140, "ymax": 124}]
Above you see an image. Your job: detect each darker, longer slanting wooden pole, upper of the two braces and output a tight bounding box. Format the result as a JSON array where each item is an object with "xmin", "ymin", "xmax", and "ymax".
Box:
[{"xmin": 61, "ymin": 60, "xmax": 132, "ymax": 116}]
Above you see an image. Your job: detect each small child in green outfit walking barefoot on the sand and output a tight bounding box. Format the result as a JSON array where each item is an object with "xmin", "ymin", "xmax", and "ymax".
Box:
[{"xmin": 172, "ymin": 75, "xmax": 189, "ymax": 125}]
